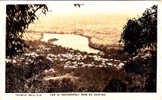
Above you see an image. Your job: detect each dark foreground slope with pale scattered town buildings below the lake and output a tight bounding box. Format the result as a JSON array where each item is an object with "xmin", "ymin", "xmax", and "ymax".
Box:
[{"xmin": 6, "ymin": 41, "xmax": 156, "ymax": 93}]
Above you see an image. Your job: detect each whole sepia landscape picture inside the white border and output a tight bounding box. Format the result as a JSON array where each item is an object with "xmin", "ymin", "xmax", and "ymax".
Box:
[{"xmin": 5, "ymin": 1, "xmax": 158, "ymax": 93}]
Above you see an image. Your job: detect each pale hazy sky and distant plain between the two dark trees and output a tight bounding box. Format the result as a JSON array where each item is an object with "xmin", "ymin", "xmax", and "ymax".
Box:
[{"xmin": 25, "ymin": 2, "xmax": 157, "ymax": 44}]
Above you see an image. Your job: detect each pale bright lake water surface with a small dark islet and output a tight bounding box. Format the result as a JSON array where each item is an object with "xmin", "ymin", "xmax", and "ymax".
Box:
[{"xmin": 42, "ymin": 33, "xmax": 99, "ymax": 53}]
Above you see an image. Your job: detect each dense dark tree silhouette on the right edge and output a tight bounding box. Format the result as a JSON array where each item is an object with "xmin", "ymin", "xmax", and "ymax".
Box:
[{"xmin": 120, "ymin": 5, "xmax": 157, "ymax": 55}]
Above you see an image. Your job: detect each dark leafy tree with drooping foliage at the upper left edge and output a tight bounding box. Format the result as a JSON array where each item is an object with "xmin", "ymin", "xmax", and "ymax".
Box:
[{"xmin": 6, "ymin": 4, "xmax": 48, "ymax": 57}]
